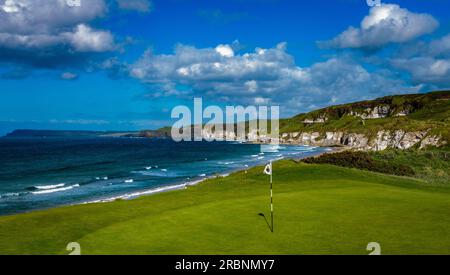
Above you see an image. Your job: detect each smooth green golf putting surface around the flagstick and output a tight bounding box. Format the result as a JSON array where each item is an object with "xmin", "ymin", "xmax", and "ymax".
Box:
[{"xmin": 0, "ymin": 161, "xmax": 450, "ymax": 254}]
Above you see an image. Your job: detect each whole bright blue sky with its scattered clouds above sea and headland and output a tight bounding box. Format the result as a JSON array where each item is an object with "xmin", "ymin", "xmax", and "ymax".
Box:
[{"xmin": 0, "ymin": 0, "xmax": 450, "ymax": 134}]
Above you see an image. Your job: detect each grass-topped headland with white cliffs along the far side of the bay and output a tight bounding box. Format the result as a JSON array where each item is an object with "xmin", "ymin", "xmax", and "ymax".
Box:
[{"xmin": 200, "ymin": 91, "xmax": 450, "ymax": 151}]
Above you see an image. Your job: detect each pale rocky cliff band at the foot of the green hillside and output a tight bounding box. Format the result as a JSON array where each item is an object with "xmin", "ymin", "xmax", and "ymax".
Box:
[{"xmin": 281, "ymin": 130, "xmax": 446, "ymax": 151}]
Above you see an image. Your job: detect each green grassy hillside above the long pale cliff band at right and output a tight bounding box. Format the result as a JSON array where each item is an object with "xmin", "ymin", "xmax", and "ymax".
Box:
[{"xmin": 280, "ymin": 91, "xmax": 450, "ymax": 142}]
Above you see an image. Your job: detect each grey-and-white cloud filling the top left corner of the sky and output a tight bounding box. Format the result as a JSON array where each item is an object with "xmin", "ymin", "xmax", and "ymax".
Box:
[{"xmin": 0, "ymin": 0, "xmax": 115, "ymax": 67}]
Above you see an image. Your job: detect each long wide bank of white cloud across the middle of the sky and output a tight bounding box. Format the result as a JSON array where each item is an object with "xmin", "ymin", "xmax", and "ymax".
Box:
[{"xmin": 130, "ymin": 43, "xmax": 417, "ymax": 114}]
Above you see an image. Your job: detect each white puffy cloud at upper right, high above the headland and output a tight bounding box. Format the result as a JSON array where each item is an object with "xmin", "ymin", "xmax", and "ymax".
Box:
[{"xmin": 319, "ymin": 4, "xmax": 439, "ymax": 49}]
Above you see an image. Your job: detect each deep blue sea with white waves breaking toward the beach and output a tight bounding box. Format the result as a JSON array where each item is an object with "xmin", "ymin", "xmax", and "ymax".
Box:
[{"xmin": 0, "ymin": 137, "xmax": 329, "ymax": 215}]
